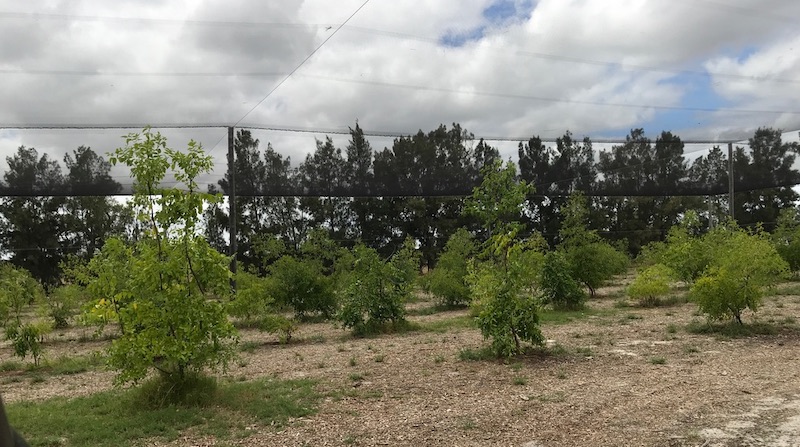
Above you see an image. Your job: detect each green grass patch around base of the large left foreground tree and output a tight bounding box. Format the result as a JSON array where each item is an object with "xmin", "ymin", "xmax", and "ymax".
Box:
[{"xmin": 7, "ymin": 379, "xmax": 321, "ymax": 447}]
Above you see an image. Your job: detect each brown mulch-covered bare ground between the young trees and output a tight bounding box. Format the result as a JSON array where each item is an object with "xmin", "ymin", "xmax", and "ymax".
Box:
[{"xmin": 0, "ymin": 285, "xmax": 800, "ymax": 447}]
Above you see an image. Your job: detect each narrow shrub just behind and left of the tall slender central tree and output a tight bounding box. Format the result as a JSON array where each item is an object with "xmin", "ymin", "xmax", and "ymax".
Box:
[{"xmin": 426, "ymin": 228, "xmax": 477, "ymax": 307}]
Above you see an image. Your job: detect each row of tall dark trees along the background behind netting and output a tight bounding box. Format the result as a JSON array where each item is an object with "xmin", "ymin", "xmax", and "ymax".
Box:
[{"xmin": 0, "ymin": 124, "xmax": 800, "ymax": 284}]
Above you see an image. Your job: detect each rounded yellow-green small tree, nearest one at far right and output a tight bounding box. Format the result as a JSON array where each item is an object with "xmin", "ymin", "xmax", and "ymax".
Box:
[{"xmin": 691, "ymin": 224, "xmax": 789, "ymax": 323}]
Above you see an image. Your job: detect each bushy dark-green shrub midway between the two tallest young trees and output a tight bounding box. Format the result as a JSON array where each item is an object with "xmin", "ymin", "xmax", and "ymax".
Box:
[{"xmin": 337, "ymin": 240, "xmax": 419, "ymax": 334}]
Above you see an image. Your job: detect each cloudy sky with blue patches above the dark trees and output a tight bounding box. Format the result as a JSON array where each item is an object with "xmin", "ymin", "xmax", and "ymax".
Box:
[{"xmin": 0, "ymin": 0, "xmax": 800, "ymax": 184}]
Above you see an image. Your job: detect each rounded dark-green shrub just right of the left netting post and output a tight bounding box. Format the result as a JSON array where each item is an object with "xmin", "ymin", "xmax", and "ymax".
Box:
[{"xmin": 267, "ymin": 256, "xmax": 336, "ymax": 319}]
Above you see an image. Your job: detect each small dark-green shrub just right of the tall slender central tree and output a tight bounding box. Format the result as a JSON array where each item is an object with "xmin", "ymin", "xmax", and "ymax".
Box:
[{"xmin": 540, "ymin": 251, "xmax": 586, "ymax": 310}]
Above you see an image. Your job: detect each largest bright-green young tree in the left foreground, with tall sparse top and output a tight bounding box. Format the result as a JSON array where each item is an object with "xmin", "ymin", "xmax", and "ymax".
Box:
[{"xmin": 101, "ymin": 128, "xmax": 235, "ymax": 397}]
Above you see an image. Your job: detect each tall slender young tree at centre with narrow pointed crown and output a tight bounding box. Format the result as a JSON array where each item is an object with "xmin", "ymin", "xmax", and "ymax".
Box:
[{"xmin": 465, "ymin": 161, "xmax": 543, "ymax": 357}]
